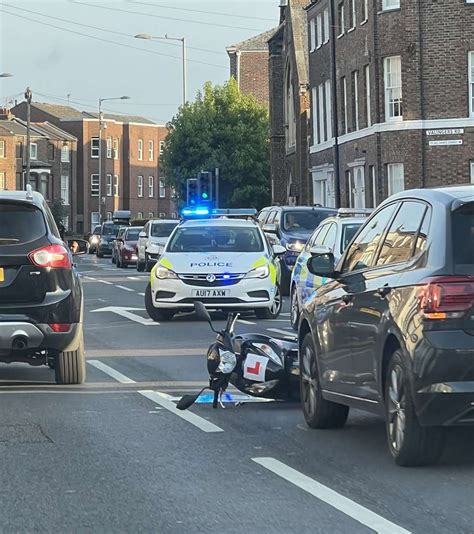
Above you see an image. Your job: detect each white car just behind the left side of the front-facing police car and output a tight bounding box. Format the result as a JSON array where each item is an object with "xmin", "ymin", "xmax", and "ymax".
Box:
[{"xmin": 137, "ymin": 219, "xmax": 179, "ymax": 272}]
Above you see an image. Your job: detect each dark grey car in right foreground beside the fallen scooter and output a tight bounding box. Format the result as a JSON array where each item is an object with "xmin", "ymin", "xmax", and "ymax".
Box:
[{"xmin": 299, "ymin": 186, "xmax": 474, "ymax": 465}]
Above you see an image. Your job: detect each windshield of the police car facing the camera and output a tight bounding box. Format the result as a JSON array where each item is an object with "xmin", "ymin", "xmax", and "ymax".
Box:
[{"xmin": 168, "ymin": 226, "xmax": 263, "ymax": 253}]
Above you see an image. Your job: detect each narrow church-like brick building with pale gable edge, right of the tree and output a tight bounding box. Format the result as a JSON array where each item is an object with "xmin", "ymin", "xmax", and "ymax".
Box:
[{"xmin": 268, "ymin": 0, "xmax": 312, "ymax": 204}]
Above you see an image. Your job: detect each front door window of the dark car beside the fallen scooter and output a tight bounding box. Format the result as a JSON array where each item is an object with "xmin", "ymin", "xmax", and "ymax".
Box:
[{"xmin": 342, "ymin": 204, "xmax": 399, "ymax": 273}]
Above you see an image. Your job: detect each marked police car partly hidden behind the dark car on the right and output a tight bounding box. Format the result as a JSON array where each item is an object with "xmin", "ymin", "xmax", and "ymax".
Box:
[{"xmin": 290, "ymin": 208, "xmax": 372, "ymax": 330}]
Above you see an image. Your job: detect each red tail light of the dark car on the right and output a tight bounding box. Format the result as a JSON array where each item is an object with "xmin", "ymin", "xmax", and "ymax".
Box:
[{"xmin": 418, "ymin": 276, "xmax": 474, "ymax": 319}]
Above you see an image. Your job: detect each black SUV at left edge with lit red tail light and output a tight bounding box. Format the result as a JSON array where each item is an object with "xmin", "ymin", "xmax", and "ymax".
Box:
[{"xmin": 0, "ymin": 191, "xmax": 86, "ymax": 384}]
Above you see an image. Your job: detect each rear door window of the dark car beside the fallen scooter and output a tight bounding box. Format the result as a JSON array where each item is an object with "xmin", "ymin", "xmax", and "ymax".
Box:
[{"xmin": 377, "ymin": 202, "xmax": 427, "ymax": 265}]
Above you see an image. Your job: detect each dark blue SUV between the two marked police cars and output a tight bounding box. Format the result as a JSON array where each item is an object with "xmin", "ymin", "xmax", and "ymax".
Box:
[{"xmin": 258, "ymin": 206, "xmax": 337, "ymax": 294}]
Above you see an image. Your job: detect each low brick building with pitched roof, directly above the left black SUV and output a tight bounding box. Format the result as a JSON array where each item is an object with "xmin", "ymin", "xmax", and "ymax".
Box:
[{"xmin": 0, "ymin": 110, "xmax": 77, "ymax": 231}]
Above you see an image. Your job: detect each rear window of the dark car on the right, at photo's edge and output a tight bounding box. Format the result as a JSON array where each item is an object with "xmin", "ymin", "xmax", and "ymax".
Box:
[{"xmin": 452, "ymin": 202, "xmax": 474, "ymax": 274}]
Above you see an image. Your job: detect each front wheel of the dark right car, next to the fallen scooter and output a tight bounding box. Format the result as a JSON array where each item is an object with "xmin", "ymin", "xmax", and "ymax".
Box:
[{"xmin": 300, "ymin": 334, "xmax": 349, "ymax": 428}]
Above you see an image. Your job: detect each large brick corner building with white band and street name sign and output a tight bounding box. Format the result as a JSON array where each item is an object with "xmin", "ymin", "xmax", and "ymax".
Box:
[{"xmin": 307, "ymin": 0, "xmax": 474, "ymax": 207}]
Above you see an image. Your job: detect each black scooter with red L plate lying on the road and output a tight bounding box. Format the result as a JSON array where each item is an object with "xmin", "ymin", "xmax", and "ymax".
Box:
[{"xmin": 177, "ymin": 302, "xmax": 299, "ymax": 410}]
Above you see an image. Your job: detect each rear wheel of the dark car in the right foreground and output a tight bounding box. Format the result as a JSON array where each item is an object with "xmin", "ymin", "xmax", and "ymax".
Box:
[{"xmin": 385, "ymin": 349, "xmax": 444, "ymax": 467}]
